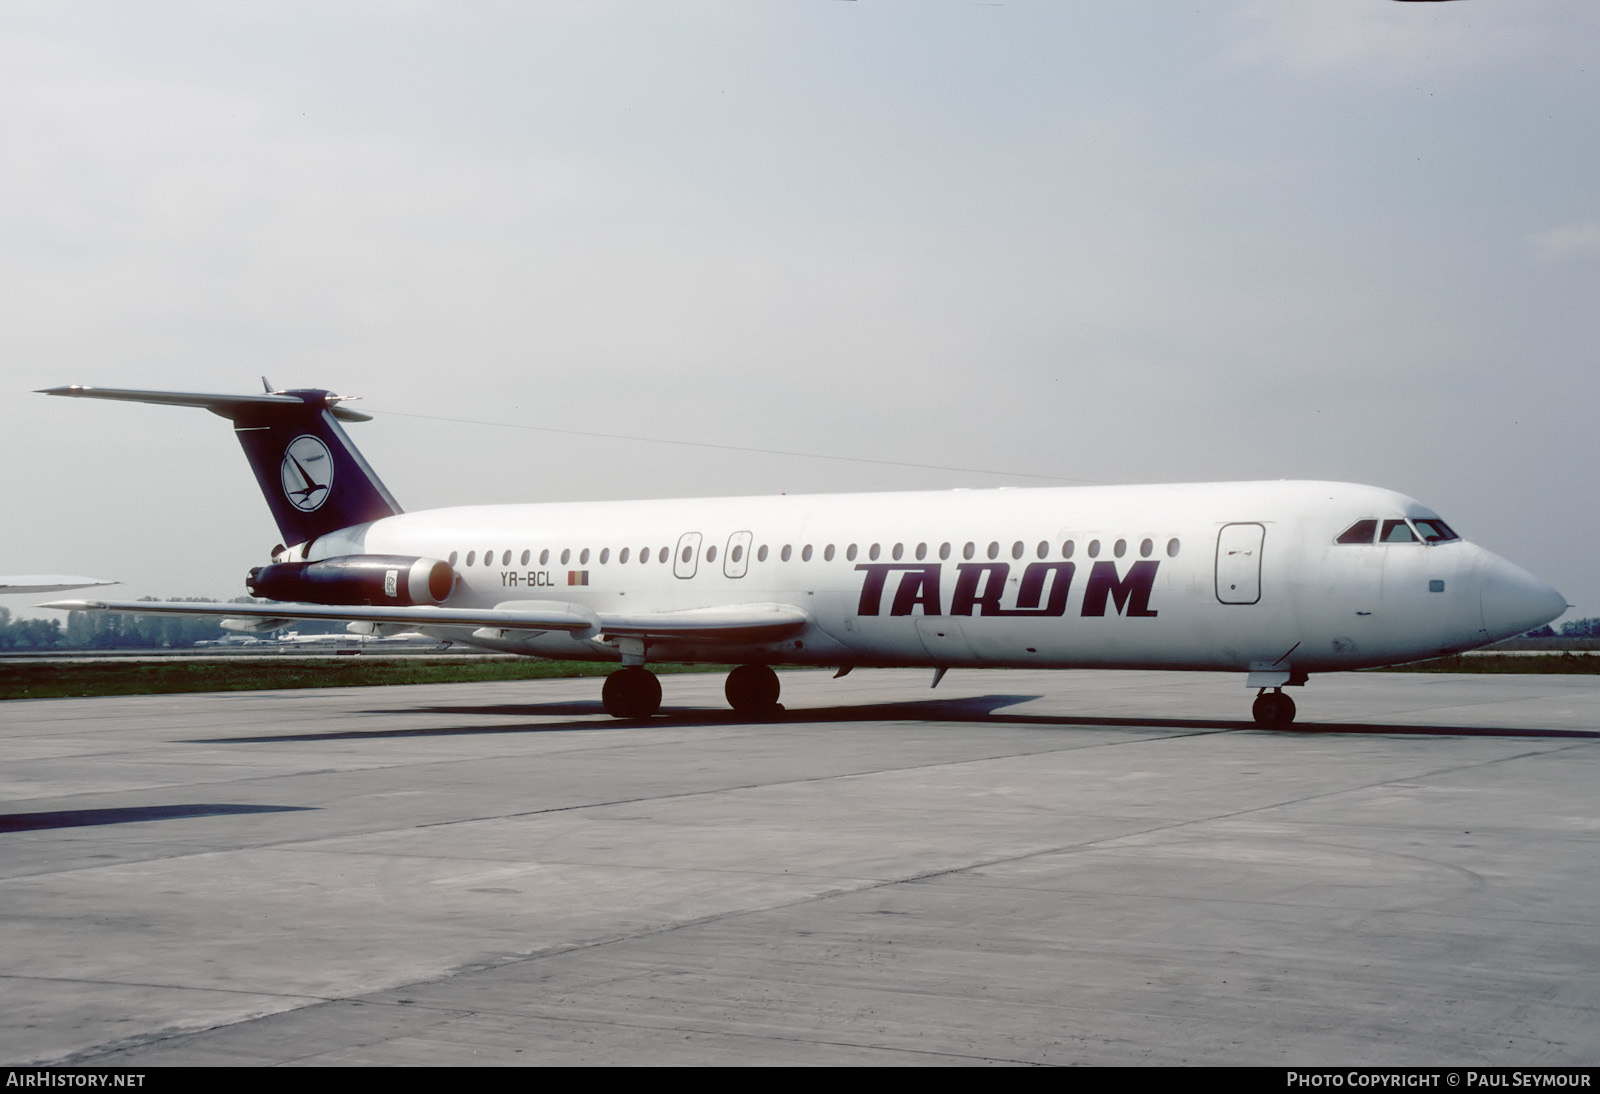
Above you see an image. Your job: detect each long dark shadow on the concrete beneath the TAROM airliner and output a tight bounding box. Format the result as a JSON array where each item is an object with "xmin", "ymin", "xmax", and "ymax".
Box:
[{"xmin": 178, "ymin": 694, "xmax": 1600, "ymax": 744}]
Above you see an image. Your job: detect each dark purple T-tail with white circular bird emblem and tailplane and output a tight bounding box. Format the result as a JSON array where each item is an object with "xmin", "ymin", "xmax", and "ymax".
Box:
[{"xmin": 40, "ymin": 384, "xmax": 400, "ymax": 544}]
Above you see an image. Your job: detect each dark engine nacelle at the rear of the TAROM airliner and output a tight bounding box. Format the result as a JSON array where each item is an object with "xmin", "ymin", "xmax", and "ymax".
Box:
[{"xmin": 245, "ymin": 555, "xmax": 456, "ymax": 608}]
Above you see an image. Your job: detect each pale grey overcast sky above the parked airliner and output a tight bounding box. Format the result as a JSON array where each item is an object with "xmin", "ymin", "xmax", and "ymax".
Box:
[{"xmin": 0, "ymin": 0, "xmax": 1600, "ymax": 616}]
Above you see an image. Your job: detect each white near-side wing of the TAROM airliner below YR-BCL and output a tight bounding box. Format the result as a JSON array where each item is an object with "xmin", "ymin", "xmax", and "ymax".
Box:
[{"xmin": 40, "ymin": 600, "xmax": 810, "ymax": 641}]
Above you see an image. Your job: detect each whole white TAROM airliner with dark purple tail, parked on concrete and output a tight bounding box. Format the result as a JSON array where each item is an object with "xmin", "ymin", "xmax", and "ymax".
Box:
[{"xmin": 34, "ymin": 385, "xmax": 1566, "ymax": 725}]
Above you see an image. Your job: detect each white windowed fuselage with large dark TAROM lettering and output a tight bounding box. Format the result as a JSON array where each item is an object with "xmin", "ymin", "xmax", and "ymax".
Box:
[{"xmin": 297, "ymin": 481, "xmax": 1565, "ymax": 673}]
